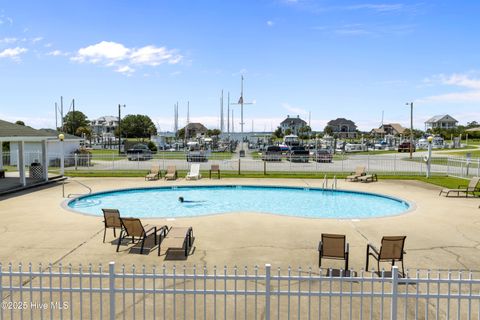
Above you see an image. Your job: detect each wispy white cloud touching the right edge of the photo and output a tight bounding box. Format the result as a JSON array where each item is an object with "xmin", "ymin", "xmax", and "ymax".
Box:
[{"xmin": 418, "ymin": 73, "xmax": 480, "ymax": 103}]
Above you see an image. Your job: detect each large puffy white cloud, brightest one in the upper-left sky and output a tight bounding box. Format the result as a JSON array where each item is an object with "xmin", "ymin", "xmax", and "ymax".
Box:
[{"xmin": 71, "ymin": 41, "xmax": 183, "ymax": 74}]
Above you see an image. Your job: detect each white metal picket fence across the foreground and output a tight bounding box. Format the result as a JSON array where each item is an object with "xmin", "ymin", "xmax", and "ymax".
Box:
[{"xmin": 0, "ymin": 262, "xmax": 480, "ymax": 319}]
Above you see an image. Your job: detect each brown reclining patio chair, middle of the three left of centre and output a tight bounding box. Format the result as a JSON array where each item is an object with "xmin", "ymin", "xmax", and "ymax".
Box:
[{"xmin": 117, "ymin": 218, "xmax": 168, "ymax": 253}]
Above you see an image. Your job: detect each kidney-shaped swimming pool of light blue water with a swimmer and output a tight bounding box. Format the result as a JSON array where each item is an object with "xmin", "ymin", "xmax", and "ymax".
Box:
[{"xmin": 66, "ymin": 185, "xmax": 410, "ymax": 219}]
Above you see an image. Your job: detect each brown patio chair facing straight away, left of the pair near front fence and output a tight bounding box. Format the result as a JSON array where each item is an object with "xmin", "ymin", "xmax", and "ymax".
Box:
[{"xmin": 318, "ymin": 233, "xmax": 349, "ymax": 270}]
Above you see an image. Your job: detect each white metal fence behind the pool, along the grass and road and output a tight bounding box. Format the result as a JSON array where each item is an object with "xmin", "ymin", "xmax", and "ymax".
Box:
[{"xmin": 3, "ymin": 153, "xmax": 480, "ymax": 177}]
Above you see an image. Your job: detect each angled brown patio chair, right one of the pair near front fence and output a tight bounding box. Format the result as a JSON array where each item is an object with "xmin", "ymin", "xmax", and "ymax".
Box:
[{"xmin": 365, "ymin": 236, "xmax": 407, "ymax": 274}]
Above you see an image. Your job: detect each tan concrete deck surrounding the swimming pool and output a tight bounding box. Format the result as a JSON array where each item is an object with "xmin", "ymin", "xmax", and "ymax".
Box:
[{"xmin": 0, "ymin": 178, "xmax": 480, "ymax": 270}]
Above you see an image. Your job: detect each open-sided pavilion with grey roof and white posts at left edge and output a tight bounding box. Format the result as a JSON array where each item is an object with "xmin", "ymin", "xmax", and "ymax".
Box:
[{"xmin": 0, "ymin": 120, "xmax": 52, "ymax": 187}]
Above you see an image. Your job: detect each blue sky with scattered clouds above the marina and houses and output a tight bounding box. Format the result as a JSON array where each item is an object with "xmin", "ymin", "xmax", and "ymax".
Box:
[{"xmin": 0, "ymin": 0, "xmax": 480, "ymax": 131}]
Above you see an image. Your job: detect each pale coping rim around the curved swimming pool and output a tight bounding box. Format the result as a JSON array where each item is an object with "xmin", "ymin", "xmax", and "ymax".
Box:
[{"xmin": 60, "ymin": 184, "xmax": 417, "ymax": 221}]
